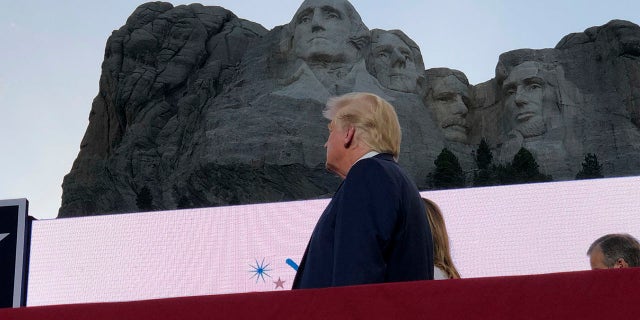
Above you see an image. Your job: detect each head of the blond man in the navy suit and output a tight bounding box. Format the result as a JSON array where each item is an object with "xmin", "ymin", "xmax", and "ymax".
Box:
[{"xmin": 322, "ymin": 92, "xmax": 402, "ymax": 178}]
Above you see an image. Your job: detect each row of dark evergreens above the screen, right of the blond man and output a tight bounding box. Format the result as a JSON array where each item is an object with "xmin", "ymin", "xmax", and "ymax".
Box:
[{"xmin": 428, "ymin": 139, "xmax": 604, "ymax": 189}]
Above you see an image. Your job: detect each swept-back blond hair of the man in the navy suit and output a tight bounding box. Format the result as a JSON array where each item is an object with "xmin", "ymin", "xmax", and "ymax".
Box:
[{"xmin": 322, "ymin": 92, "xmax": 402, "ymax": 161}]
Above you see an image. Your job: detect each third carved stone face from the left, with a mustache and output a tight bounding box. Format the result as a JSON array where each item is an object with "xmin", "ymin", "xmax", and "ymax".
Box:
[{"xmin": 427, "ymin": 75, "xmax": 471, "ymax": 143}]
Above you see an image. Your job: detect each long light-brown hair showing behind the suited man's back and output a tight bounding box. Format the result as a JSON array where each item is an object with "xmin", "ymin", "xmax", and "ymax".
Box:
[{"xmin": 422, "ymin": 198, "xmax": 460, "ymax": 279}]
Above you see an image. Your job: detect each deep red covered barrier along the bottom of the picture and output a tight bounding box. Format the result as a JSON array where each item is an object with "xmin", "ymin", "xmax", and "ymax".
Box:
[{"xmin": 0, "ymin": 268, "xmax": 640, "ymax": 320}]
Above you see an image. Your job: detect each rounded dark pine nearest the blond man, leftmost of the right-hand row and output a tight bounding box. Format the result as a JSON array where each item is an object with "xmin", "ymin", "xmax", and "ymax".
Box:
[{"xmin": 429, "ymin": 148, "xmax": 464, "ymax": 189}]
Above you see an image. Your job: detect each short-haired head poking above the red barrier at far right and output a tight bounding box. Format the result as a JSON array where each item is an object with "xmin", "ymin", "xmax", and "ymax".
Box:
[{"xmin": 587, "ymin": 234, "xmax": 640, "ymax": 270}]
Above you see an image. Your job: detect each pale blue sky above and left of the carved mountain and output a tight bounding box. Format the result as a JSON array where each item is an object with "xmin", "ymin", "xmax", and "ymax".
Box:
[{"xmin": 0, "ymin": 0, "xmax": 640, "ymax": 219}]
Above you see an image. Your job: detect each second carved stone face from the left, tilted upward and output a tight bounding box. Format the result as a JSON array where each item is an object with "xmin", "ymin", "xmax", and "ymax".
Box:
[{"xmin": 371, "ymin": 31, "xmax": 422, "ymax": 92}]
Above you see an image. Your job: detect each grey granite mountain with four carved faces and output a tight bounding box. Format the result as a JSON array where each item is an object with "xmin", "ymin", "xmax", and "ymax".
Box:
[{"xmin": 58, "ymin": 0, "xmax": 640, "ymax": 217}]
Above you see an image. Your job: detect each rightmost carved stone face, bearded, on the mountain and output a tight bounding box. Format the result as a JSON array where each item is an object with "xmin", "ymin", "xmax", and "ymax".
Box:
[{"xmin": 502, "ymin": 61, "xmax": 559, "ymax": 138}]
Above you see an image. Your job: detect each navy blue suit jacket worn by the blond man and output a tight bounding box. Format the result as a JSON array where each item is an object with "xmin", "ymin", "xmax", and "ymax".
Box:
[{"xmin": 293, "ymin": 154, "xmax": 433, "ymax": 289}]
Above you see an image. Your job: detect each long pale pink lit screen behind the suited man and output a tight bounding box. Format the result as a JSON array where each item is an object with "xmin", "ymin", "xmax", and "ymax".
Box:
[{"xmin": 27, "ymin": 177, "xmax": 640, "ymax": 306}]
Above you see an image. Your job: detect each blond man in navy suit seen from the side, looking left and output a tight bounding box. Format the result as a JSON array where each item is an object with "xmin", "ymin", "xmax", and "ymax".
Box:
[{"xmin": 293, "ymin": 93, "xmax": 433, "ymax": 289}]
